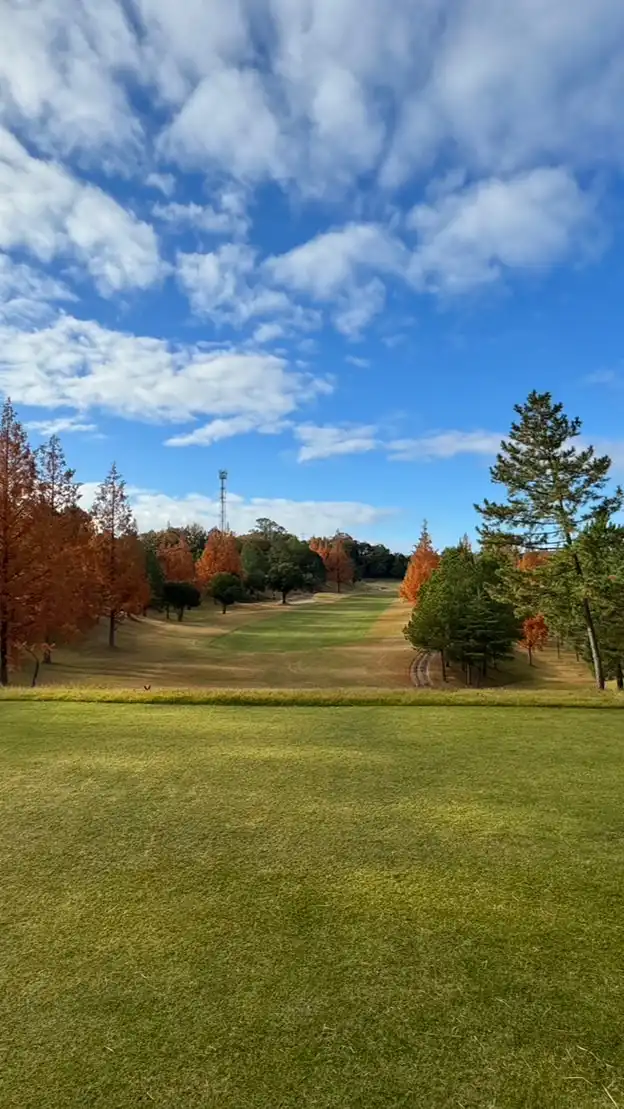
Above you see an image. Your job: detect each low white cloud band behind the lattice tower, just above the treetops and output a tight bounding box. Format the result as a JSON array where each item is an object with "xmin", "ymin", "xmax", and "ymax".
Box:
[{"xmin": 104, "ymin": 482, "xmax": 395, "ymax": 538}]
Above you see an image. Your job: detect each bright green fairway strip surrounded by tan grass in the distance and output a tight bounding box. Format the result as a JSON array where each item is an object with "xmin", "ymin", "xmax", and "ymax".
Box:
[{"xmin": 211, "ymin": 593, "xmax": 396, "ymax": 653}]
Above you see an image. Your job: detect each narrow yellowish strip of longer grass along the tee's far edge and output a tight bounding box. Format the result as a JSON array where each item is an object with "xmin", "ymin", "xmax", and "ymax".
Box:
[{"xmin": 0, "ymin": 686, "xmax": 624, "ymax": 709}]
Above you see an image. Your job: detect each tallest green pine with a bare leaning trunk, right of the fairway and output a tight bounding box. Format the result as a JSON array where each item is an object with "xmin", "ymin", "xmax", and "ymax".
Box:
[{"xmin": 475, "ymin": 391, "xmax": 623, "ymax": 690}]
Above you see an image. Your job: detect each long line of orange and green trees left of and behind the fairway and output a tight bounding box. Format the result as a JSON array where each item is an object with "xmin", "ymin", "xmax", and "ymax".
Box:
[{"xmin": 0, "ymin": 400, "xmax": 408, "ymax": 685}]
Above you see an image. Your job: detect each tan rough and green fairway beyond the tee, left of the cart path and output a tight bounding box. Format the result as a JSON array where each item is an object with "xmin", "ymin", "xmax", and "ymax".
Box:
[{"xmin": 12, "ymin": 587, "xmax": 413, "ymax": 690}]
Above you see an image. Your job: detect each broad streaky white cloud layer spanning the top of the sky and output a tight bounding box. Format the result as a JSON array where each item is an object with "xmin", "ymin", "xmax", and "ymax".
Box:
[{"xmin": 0, "ymin": 0, "xmax": 624, "ymax": 196}]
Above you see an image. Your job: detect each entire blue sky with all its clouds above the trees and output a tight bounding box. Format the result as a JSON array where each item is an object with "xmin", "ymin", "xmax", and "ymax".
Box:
[{"xmin": 0, "ymin": 0, "xmax": 624, "ymax": 550}]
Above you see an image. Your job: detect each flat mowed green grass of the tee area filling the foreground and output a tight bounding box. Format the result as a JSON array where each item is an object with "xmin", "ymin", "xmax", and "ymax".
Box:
[{"xmin": 0, "ymin": 702, "xmax": 624, "ymax": 1109}]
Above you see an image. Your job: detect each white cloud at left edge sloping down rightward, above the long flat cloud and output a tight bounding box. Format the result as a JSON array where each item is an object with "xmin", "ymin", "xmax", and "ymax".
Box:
[{"xmin": 0, "ymin": 128, "xmax": 162, "ymax": 295}]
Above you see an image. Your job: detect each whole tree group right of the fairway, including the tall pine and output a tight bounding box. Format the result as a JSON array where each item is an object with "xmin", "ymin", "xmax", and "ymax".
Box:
[{"xmin": 401, "ymin": 390, "xmax": 624, "ymax": 690}]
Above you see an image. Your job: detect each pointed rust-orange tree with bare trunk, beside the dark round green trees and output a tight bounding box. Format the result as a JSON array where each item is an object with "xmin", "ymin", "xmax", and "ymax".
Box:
[{"xmin": 91, "ymin": 462, "xmax": 150, "ymax": 647}]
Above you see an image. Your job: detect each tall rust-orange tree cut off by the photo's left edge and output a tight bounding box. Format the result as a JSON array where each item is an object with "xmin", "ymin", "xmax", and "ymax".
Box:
[{"xmin": 0, "ymin": 400, "xmax": 47, "ymax": 685}]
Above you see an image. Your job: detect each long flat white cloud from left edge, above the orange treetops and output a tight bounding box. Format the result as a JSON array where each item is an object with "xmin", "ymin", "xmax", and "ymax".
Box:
[{"xmin": 0, "ymin": 316, "xmax": 330, "ymax": 439}]
